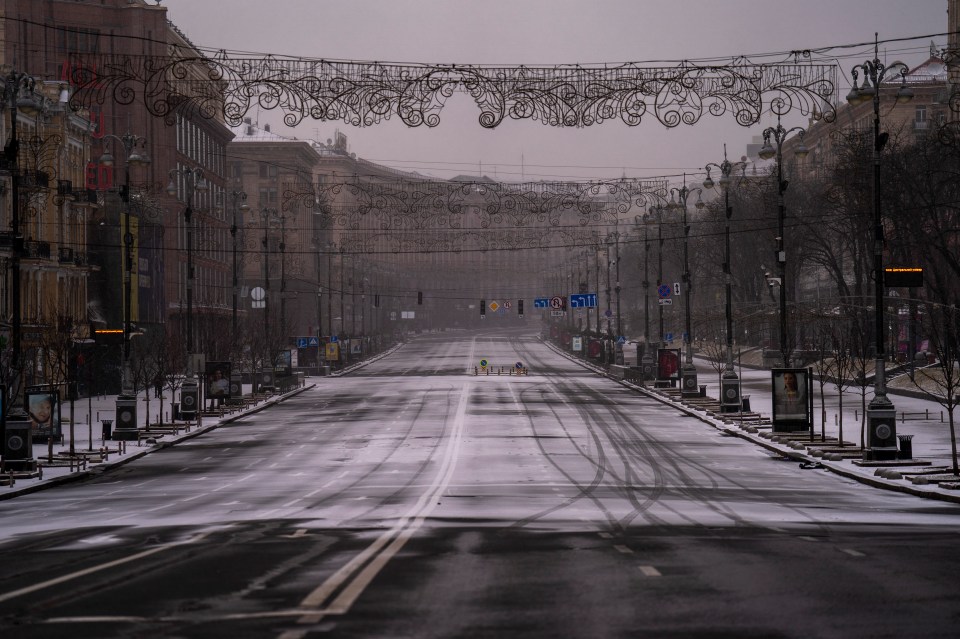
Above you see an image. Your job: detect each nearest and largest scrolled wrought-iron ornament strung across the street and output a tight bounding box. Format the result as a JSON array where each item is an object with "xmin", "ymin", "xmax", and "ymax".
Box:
[{"xmin": 71, "ymin": 49, "xmax": 837, "ymax": 129}]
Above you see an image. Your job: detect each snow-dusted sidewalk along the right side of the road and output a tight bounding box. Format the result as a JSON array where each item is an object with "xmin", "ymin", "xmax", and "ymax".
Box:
[{"xmin": 568, "ymin": 341, "xmax": 960, "ymax": 503}]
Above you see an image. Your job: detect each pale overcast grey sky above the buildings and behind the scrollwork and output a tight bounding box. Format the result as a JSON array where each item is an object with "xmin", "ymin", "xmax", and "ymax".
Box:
[{"xmin": 163, "ymin": 0, "xmax": 947, "ymax": 181}]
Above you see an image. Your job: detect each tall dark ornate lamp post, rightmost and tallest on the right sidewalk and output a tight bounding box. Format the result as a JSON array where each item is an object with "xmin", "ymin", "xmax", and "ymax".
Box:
[{"xmin": 847, "ymin": 34, "xmax": 913, "ymax": 460}]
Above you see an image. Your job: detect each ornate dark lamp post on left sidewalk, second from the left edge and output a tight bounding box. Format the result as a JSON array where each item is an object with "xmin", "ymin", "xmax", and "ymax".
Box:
[{"xmin": 100, "ymin": 133, "xmax": 150, "ymax": 440}]
